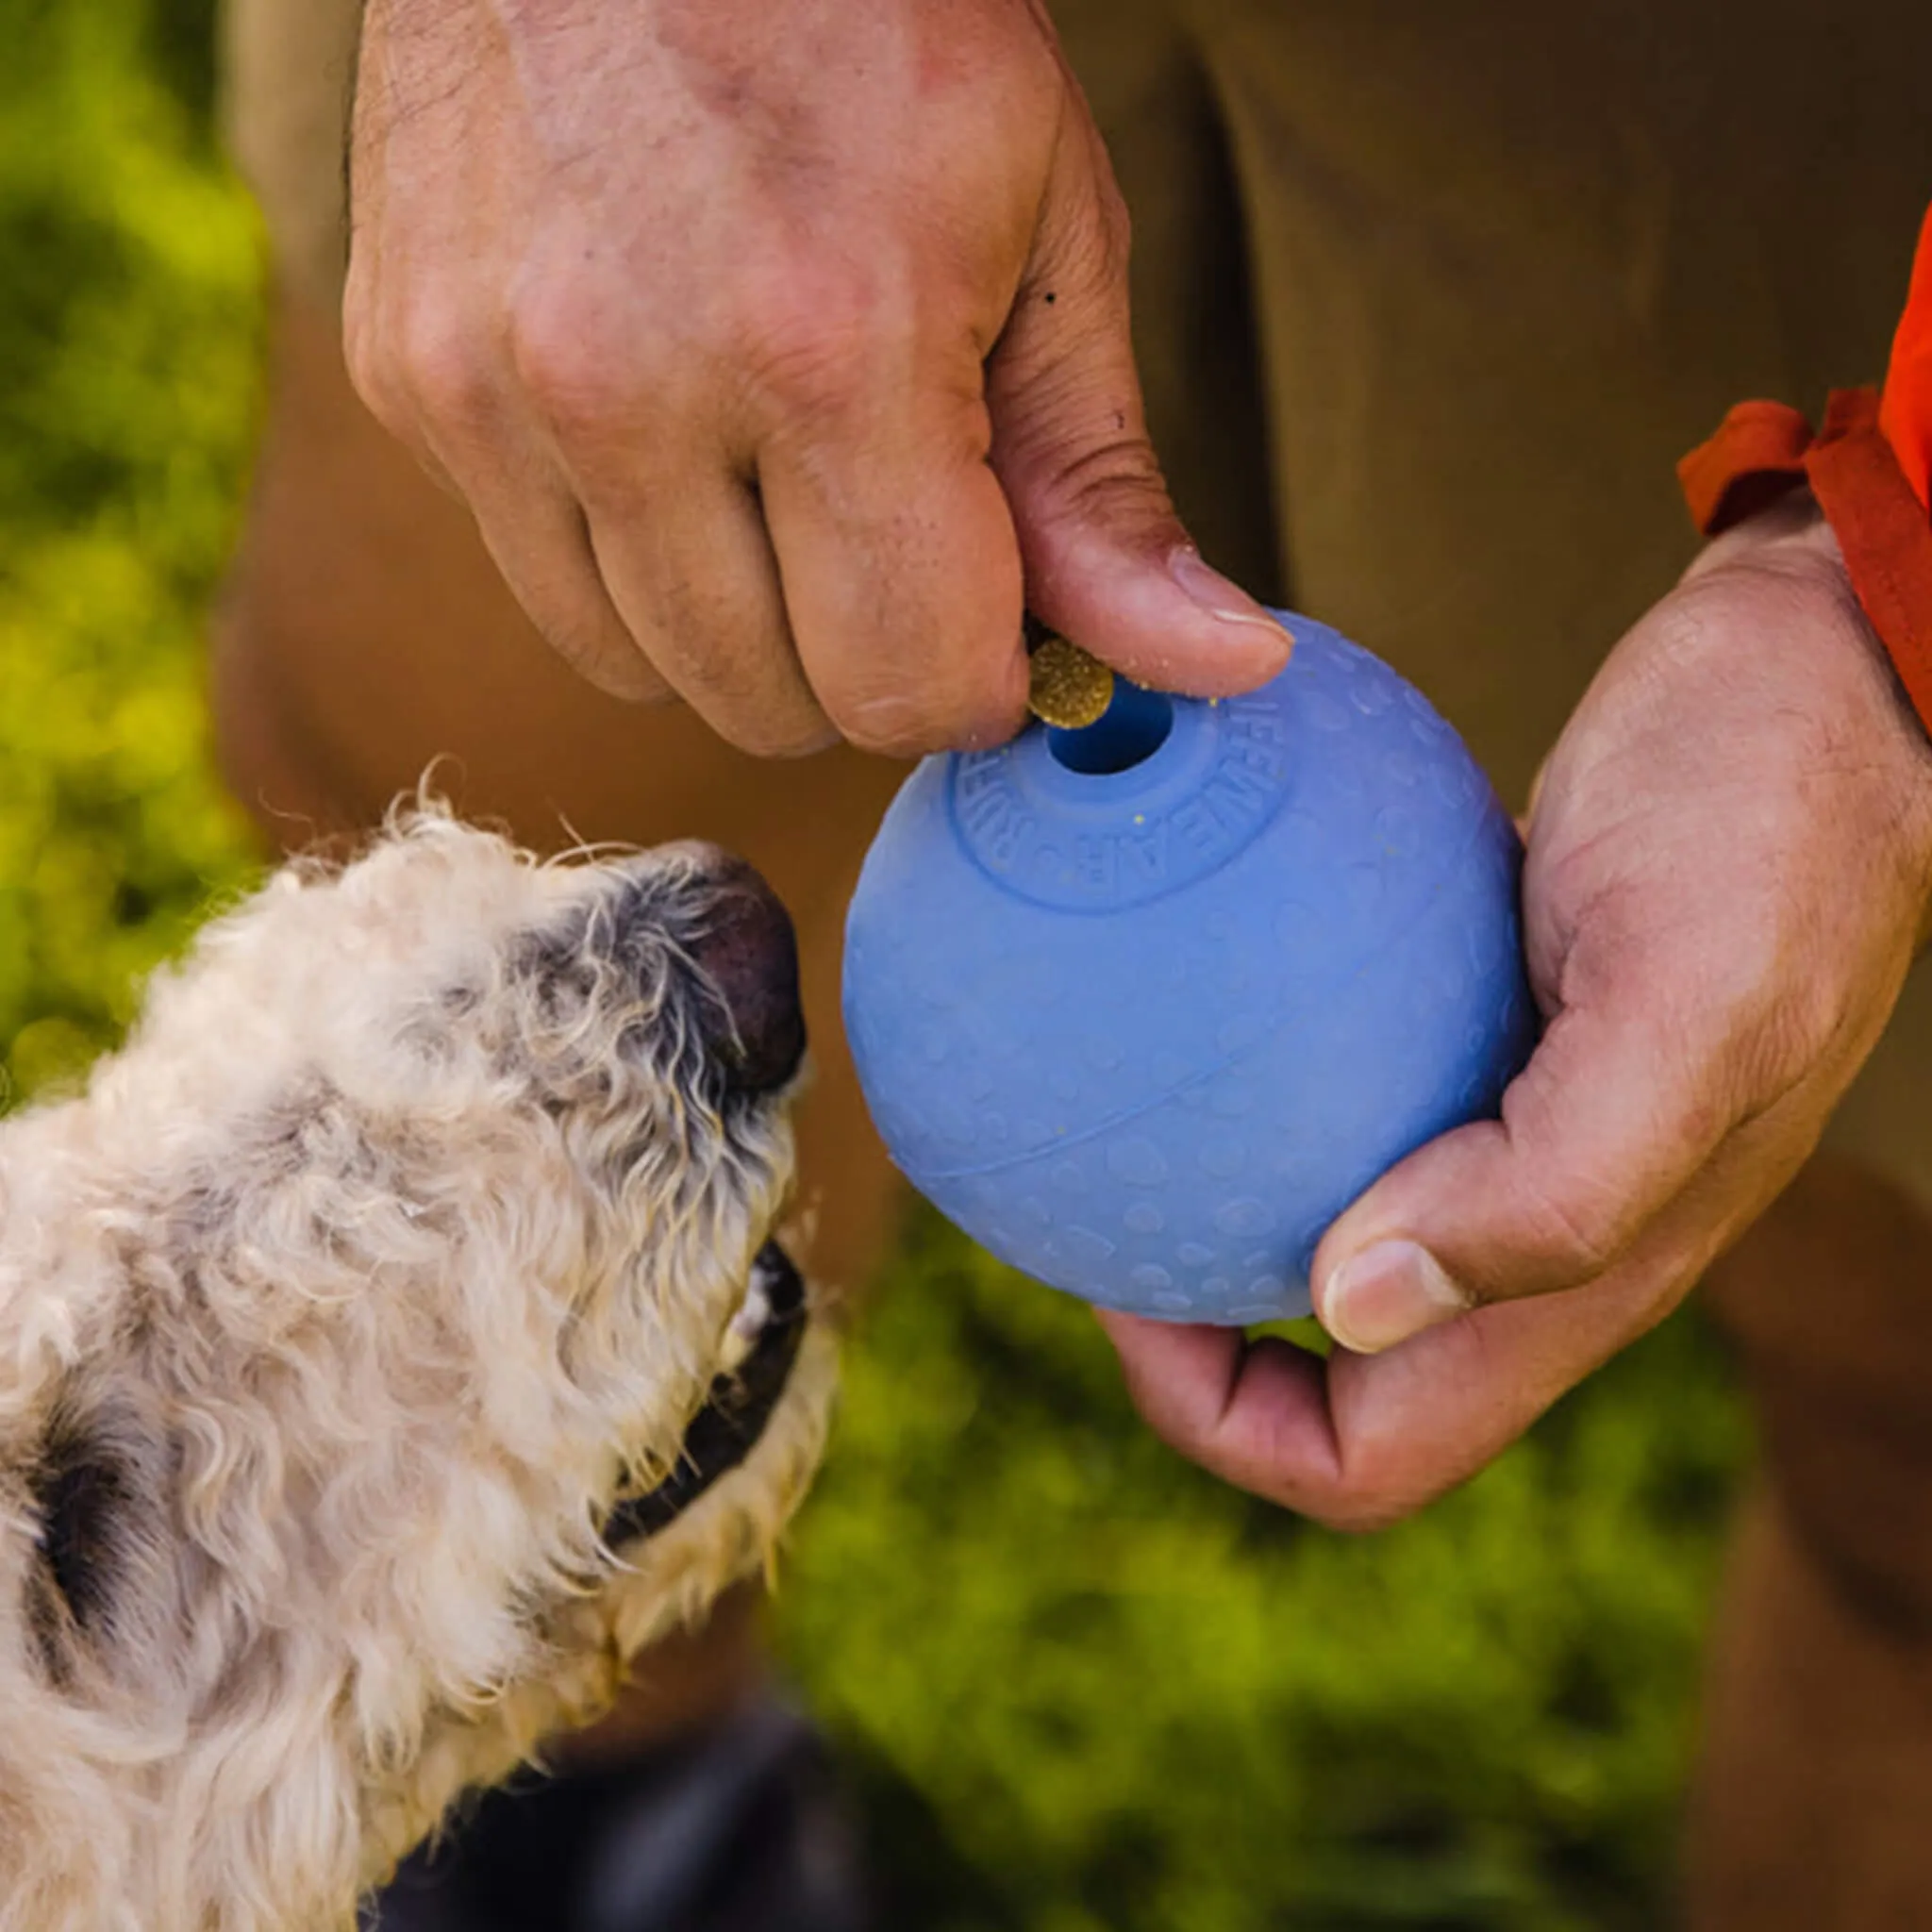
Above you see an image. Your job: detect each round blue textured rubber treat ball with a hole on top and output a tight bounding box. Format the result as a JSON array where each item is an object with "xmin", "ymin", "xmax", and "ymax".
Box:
[{"xmin": 844, "ymin": 616, "xmax": 1536, "ymax": 1324}]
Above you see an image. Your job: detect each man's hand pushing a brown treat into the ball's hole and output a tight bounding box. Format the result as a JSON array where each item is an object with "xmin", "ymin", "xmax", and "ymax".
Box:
[{"xmin": 344, "ymin": 0, "xmax": 1287, "ymax": 754}]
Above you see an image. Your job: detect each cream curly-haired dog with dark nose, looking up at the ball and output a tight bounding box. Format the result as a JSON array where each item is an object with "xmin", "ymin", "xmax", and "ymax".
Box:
[{"xmin": 0, "ymin": 811, "xmax": 833, "ymax": 1932}]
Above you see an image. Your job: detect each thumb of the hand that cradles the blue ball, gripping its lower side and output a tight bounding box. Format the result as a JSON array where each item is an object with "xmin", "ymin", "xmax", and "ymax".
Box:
[{"xmin": 1312, "ymin": 1008, "xmax": 1735, "ymax": 1355}]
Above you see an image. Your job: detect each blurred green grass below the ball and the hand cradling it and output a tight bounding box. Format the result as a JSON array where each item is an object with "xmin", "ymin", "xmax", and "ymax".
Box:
[{"xmin": 780, "ymin": 1221, "xmax": 1742, "ymax": 1932}]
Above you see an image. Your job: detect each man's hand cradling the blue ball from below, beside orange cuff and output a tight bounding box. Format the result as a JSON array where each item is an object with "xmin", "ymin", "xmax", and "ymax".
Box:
[{"xmin": 1105, "ymin": 500, "xmax": 1932, "ymax": 1528}]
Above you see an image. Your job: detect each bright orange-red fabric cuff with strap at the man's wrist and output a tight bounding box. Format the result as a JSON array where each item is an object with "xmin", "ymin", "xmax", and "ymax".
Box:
[{"xmin": 1677, "ymin": 210, "xmax": 1932, "ymax": 732}]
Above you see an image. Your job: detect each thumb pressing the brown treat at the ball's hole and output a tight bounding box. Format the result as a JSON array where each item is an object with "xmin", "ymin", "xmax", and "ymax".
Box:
[{"xmin": 985, "ymin": 103, "xmax": 1289, "ymax": 697}]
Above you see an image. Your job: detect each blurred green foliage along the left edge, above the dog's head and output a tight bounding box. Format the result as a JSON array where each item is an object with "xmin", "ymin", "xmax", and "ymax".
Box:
[{"xmin": 0, "ymin": 0, "xmax": 260, "ymax": 1093}]
